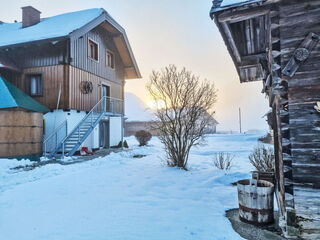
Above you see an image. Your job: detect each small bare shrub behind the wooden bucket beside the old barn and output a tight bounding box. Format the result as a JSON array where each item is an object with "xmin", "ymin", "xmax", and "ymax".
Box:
[{"xmin": 249, "ymin": 145, "xmax": 275, "ymax": 172}]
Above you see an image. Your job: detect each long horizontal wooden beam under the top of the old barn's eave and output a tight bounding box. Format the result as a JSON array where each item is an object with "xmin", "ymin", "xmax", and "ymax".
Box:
[{"xmin": 218, "ymin": 7, "xmax": 270, "ymax": 23}]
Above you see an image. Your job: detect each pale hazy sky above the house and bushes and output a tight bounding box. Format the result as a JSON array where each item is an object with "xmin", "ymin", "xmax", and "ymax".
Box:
[{"xmin": 0, "ymin": 0, "xmax": 269, "ymax": 130}]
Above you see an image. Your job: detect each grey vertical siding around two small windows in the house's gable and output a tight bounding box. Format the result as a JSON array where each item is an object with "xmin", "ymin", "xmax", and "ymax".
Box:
[{"xmin": 70, "ymin": 26, "xmax": 125, "ymax": 83}]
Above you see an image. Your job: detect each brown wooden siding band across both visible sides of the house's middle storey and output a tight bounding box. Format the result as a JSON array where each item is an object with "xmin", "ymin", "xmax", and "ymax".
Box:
[{"xmin": 1, "ymin": 65, "xmax": 124, "ymax": 111}]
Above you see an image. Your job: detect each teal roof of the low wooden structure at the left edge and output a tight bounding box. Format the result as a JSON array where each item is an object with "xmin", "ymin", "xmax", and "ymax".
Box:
[{"xmin": 0, "ymin": 76, "xmax": 50, "ymax": 113}]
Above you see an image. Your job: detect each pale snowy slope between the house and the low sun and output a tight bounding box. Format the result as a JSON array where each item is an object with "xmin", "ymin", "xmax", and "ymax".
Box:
[{"xmin": 124, "ymin": 92, "xmax": 154, "ymax": 121}]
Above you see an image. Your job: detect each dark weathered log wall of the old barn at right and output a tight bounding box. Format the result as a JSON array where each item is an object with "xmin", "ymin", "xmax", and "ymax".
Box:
[{"xmin": 279, "ymin": 0, "xmax": 320, "ymax": 239}]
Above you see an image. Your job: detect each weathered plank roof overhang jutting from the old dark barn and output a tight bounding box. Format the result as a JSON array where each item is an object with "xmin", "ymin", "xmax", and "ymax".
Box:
[{"xmin": 210, "ymin": 0, "xmax": 280, "ymax": 82}]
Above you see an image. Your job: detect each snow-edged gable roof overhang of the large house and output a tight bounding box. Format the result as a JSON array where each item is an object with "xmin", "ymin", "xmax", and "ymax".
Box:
[{"xmin": 69, "ymin": 11, "xmax": 141, "ymax": 79}]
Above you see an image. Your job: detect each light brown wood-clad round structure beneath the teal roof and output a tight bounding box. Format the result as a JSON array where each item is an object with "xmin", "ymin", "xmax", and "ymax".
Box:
[{"xmin": 0, "ymin": 110, "xmax": 43, "ymax": 159}]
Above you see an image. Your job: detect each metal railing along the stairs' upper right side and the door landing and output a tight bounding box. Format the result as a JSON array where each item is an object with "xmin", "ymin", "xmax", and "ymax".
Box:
[{"xmin": 60, "ymin": 96, "xmax": 124, "ymax": 157}]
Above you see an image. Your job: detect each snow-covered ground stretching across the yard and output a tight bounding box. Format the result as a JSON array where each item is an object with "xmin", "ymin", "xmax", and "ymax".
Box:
[{"xmin": 0, "ymin": 134, "xmax": 258, "ymax": 240}]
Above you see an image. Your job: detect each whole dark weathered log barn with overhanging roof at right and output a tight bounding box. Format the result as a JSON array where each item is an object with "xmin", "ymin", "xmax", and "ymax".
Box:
[{"xmin": 210, "ymin": 0, "xmax": 320, "ymax": 239}]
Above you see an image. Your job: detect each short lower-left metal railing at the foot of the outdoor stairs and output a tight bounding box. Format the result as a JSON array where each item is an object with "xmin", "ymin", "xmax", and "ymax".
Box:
[{"xmin": 43, "ymin": 120, "xmax": 68, "ymax": 157}]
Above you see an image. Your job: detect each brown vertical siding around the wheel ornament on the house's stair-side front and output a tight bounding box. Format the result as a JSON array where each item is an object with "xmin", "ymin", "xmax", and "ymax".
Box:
[{"xmin": 69, "ymin": 66, "xmax": 123, "ymax": 111}]
